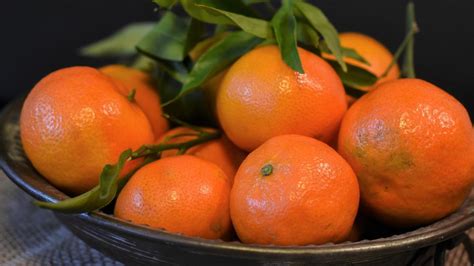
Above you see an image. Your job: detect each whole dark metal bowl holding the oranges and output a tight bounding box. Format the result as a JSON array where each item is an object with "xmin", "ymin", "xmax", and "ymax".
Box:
[{"xmin": 0, "ymin": 99, "xmax": 474, "ymax": 265}]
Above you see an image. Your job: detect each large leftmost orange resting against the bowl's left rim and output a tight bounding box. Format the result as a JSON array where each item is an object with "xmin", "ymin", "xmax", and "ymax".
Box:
[{"xmin": 20, "ymin": 67, "xmax": 154, "ymax": 194}]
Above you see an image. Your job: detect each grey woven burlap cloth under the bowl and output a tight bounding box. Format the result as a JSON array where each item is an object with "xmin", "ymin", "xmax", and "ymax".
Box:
[{"xmin": 0, "ymin": 171, "xmax": 473, "ymax": 266}]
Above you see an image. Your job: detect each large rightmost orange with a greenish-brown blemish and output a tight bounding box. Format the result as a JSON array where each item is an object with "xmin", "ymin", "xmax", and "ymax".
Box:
[{"xmin": 338, "ymin": 79, "xmax": 474, "ymax": 227}]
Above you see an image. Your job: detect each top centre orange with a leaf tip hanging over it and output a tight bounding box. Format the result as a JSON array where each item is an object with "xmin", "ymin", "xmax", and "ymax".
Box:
[{"xmin": 216, "ymin": 45, "xmax": 347, "ymax": 151}]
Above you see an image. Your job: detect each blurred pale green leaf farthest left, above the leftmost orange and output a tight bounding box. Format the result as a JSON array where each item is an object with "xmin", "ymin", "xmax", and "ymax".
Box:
[{"xmin": 79, "ymin": 22, "xmax": 154, "ymax": 57}]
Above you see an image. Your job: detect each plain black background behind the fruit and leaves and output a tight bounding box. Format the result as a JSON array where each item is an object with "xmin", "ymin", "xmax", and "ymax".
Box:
[{"xmin": 0, "ymin": 0, "xmax": 474, "ymax": 117}]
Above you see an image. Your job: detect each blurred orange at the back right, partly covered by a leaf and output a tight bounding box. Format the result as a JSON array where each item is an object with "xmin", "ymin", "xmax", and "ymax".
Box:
[{"xmin": 339, "ymin": 32, "xmax": 400, "ymax": 90}]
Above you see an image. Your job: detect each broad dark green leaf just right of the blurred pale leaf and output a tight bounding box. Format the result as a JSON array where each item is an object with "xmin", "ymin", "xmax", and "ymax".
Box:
[{"xmin": 137, "ymin": 11, "xmax": 204, "ymax": 61}]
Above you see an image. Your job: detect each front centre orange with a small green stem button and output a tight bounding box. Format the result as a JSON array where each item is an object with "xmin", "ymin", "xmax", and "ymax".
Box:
[{"xmin": 230, "ymin": 135, "xmax": 359, "ymax": 245}]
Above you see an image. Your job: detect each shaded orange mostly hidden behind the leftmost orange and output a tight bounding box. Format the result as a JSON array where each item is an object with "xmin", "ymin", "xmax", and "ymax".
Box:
[{"xmin": 100, "ymin": 65, "xmax": 168, "ymax": 138}]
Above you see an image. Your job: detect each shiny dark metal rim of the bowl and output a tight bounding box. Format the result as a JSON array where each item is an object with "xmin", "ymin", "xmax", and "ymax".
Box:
[{"xmin": 0, "ymin": 97, "xmax": 474, "ymax": 257}]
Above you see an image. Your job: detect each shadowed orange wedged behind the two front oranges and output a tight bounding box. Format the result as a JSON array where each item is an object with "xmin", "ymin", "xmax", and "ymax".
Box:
[{"xmin": 160, "ymin": 127, "xmax": 246, "ymax": 184}]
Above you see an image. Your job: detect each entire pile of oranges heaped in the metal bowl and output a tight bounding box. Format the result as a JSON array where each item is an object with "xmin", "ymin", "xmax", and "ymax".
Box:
[{"xmin": 20, "ymin": 33, "xmax": 474, "ymax": 245}]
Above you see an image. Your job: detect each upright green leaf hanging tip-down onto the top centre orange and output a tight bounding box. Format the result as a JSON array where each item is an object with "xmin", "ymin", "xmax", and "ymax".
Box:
[{"xmin": 272, "ymin": 0, "xmax": 304, "ymax": 73}]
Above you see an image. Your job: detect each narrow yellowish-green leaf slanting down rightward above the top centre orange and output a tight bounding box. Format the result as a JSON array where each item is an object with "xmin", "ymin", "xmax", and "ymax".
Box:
[{"xmin": 196, "ymin": 5, "xmax": 273, "ymax": 39}]
